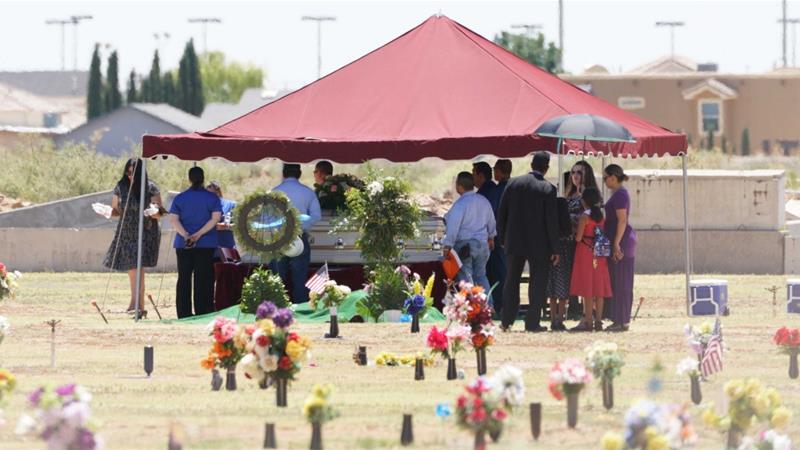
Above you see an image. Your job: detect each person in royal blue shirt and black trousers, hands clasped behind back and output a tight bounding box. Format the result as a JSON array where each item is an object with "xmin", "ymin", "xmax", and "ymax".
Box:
[{"xmin": 169, "ymin": 167, "xmax": 222, "ymax": 319}]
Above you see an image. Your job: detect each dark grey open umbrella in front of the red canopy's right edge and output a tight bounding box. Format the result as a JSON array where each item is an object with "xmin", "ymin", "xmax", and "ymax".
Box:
[{"xmin": 534, "ymin": 114, "xmax": 636, "ymax": 142}]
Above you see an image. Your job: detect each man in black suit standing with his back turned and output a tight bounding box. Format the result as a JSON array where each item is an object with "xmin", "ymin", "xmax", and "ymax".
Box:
[{"xmin": 497, "ymin": 152, "xmax": 559, "ymax": 332}]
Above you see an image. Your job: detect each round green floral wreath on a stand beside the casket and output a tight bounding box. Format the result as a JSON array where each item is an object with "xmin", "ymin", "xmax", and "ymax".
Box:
[{"xmin": 233, "ymin": 190, "xmax": 301, "ymax": 260}]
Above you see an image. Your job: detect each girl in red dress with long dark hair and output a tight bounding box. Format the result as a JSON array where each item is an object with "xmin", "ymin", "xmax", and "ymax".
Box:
[{"xmin": 569, "ymin": 188, "xmax": 612, "ymax": 331}]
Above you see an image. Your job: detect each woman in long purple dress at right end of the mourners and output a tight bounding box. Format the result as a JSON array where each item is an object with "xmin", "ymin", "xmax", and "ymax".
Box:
[{"xmin": 603, "ymin": 164, "xmax": 636, "ymax": 332}]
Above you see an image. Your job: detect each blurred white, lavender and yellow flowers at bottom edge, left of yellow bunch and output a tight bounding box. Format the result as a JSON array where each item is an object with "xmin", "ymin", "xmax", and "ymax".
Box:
[{"xmin": 601, "ymin": 400, "xmax": 697, "ymax": 450}]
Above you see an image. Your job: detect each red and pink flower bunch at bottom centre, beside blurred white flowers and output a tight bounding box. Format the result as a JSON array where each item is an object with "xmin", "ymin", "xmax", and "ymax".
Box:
[{"xmin": 456, "ymin": 377, "xmax": 508, "ymax": 437}]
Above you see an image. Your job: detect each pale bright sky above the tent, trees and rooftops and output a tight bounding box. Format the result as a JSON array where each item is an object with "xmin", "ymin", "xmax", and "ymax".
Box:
[{"xmin": 0, "ymin": 0, "xmax": 800, "ymax": 89}]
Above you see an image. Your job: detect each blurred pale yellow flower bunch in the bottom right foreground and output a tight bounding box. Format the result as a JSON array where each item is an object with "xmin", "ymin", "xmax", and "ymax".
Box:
[{"xmin": 703, "ymin": 378, "xmax": 792, "ymax": 447}]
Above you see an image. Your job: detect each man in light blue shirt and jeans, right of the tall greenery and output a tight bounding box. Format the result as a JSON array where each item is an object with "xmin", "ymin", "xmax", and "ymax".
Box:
[{"xmin": 442, "ymin": 172, "xmax": 497, "ymax": 292}]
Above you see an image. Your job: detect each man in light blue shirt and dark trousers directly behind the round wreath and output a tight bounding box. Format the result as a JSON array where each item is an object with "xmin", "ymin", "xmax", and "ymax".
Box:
[{"xmin": 271, "ymin": 164, "xmax": 322, "ymax": 303}]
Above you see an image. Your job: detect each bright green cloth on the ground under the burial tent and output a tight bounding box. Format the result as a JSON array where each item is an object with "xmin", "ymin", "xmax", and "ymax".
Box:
[{"xmin": 161, "ymin": 290, "xmax": 444, "ymax": 324}]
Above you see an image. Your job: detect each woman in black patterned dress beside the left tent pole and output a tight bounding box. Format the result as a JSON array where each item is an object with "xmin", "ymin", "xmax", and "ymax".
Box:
[{"xmin": 103, "ymin": 158, "xmax": 163, "ymax": 312}]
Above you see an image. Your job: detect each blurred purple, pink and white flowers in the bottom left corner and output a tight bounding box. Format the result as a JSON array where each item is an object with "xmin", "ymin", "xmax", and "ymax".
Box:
[{"xmin": 17, "ymin": 384, "xmax": 103, "ymax": 450}]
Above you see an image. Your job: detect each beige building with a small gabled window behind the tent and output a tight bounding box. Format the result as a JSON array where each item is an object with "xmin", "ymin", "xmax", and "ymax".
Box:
[{"xmin": 562, "ymin": 57, "xmax": 800, "ymax": 155}]
